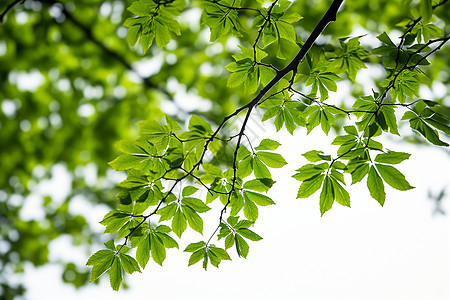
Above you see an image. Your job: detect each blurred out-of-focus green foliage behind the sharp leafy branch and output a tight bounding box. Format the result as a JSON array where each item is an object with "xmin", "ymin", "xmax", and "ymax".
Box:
[{"xmin": 0, "ymin": 0, "xmax": 450, "ymax": 299}]
